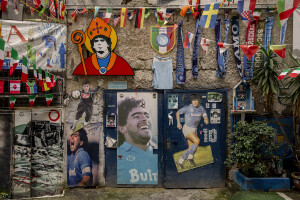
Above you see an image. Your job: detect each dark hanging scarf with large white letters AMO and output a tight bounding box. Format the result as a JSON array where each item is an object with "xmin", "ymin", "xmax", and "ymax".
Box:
[{"xmin": 231, "ymin": 16, "xmax": 243, "ymax": 78}]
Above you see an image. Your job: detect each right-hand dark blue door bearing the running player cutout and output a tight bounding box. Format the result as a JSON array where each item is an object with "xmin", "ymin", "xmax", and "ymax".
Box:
[{"xmin": 163, "ymin": 90, "xmax": 227, "ymax": 188}]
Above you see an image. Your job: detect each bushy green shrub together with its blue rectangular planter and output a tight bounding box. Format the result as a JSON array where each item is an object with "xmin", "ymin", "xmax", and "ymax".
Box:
[{"xmin": 225, "ymin": 121, "xmax": 290, "ymax": 191}]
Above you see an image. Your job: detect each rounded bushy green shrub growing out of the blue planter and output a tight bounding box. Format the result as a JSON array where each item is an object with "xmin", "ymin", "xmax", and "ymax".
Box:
[{"xmin": 225, "ymin": 121, "xmax": 278, "ymax": 176}]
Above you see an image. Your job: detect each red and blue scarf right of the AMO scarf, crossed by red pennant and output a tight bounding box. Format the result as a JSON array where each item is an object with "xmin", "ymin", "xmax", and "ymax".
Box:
[{"xmin": 243, "ymin": 20, "xmax": 257, "ymax": 80}]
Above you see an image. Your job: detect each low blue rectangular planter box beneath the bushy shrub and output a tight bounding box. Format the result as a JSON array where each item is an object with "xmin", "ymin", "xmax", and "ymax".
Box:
[{"xmin": 234, "ymin": 170, "xmax": 290, "ymax": 192}]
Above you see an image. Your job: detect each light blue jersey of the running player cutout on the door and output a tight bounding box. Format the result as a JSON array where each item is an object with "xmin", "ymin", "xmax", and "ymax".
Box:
[{"xmin": 178, "ymin": 104, "xmax": 207, "ymax": 128}]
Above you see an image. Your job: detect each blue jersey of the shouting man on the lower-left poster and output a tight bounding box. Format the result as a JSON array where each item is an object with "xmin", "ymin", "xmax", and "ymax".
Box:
[{"xmin": 68, "ymin": 148, "xmax": 93, "ymax": 186}]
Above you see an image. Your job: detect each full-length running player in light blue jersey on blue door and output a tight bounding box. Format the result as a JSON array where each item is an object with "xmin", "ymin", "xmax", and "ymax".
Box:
[{"xmin": 176, "ymin": 94, "xmax": 208, "ymax": 169}]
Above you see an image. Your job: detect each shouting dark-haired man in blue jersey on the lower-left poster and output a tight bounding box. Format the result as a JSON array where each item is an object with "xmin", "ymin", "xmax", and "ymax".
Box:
[{"xmin": 67, "ymin": 128, "xmax": 93, "ymax": 186}]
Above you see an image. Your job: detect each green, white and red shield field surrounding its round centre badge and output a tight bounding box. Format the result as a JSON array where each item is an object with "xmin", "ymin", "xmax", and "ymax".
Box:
[{"xmin": 151, "ymin": 25, "xmax": 175, "ymax": 54}]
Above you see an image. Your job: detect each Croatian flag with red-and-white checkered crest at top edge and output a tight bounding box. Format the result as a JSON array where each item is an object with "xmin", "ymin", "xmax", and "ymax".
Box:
[{"xmin": 237, "ymin": 0, "xmax": 256, "ymax": 26}]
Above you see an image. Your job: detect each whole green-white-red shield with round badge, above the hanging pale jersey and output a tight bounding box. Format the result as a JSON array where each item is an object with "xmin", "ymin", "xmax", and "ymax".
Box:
[{"xmin": 150, "ymin": 26, "xmax": 176, "ymax": 54}]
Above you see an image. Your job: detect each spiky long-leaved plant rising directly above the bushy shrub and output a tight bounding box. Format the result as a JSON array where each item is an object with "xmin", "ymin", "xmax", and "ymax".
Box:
[{"xmin": 251, "ymin": 44, "xmax": 281, "ymax": 112}]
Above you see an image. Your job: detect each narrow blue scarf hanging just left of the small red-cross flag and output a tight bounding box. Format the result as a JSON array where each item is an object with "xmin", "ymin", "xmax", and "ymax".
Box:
[{"xmin": 192, "ymin": 17, "xmax": 201, "ymax": 78}]
